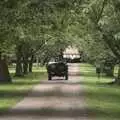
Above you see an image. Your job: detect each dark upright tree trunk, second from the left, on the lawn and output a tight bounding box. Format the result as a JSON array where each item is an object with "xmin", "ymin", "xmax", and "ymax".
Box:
[{"xmin": 15, "ymin": 46, "xmax": 23, "ymax": 77}]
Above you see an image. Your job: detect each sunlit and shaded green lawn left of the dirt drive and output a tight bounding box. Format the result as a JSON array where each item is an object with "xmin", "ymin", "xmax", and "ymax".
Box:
[{"xmin": 0, "ymin": 67, "xmax": 47, "ymax": 113}]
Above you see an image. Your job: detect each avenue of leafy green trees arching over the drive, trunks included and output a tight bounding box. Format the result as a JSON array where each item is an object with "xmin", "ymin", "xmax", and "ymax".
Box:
[{"xmin": 0, "ymin": 0, "xmax": 120, "ymax": 83}]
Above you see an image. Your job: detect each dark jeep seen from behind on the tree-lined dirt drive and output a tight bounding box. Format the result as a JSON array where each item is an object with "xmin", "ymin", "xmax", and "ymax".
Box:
[{"xmin": 47, "ymin": 62, "xmax": 68, "ymax": 80}]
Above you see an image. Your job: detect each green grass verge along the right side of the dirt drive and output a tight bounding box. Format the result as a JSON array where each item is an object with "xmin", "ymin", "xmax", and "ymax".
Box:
[{"xmin": 80, "ymin": 64, "xmax": 120, "ymax": 120}]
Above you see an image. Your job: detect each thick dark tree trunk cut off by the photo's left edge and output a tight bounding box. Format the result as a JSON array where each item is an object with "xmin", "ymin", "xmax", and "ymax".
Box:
[{"xmin": 0, "ymin": 53, "xmax": 12, "ymax": 83}]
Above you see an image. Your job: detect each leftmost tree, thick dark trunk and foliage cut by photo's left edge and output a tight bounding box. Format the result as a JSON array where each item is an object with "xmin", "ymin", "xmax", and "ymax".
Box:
[{"xmin": 0, "ymin": 1, "xmax": 16, "ymax": 82}]
